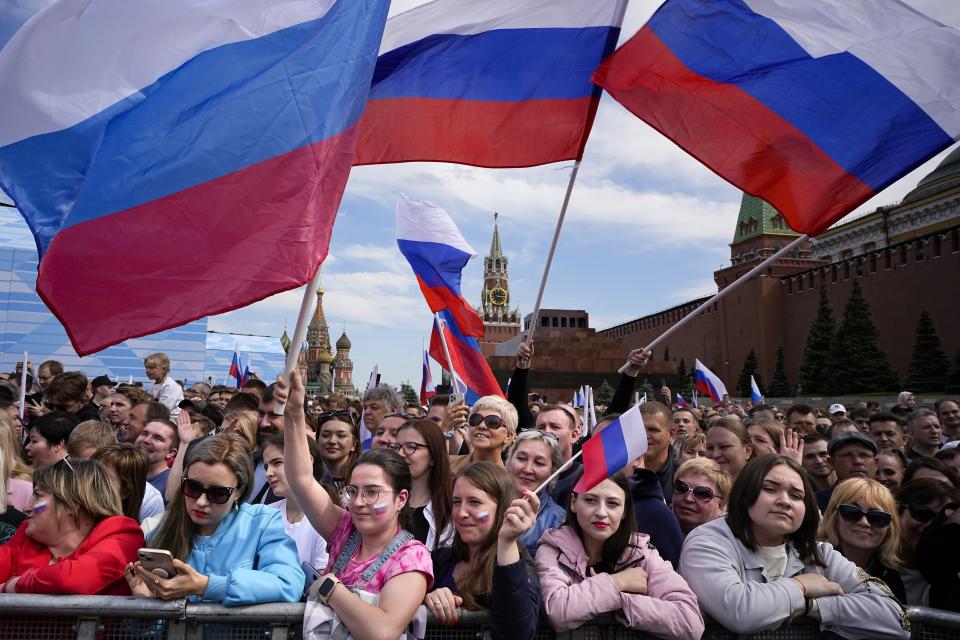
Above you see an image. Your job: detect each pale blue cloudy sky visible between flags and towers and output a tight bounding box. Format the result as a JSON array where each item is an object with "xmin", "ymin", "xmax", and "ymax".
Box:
[{"xmin": 0, "ymin": 0, "xmax": 960, "ymax": 388}]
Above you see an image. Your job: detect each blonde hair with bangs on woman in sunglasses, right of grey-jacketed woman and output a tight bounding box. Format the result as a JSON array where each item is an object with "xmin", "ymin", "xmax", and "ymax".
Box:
[{"xmin": 817, "ymin": 478, "xmax": 900, "ymax": 569}]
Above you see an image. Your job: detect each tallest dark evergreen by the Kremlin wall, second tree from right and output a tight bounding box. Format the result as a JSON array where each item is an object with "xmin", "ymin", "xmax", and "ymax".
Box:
[{"xmin": 824, "ymin": 280, "xmax": 899, "ymax": 394}]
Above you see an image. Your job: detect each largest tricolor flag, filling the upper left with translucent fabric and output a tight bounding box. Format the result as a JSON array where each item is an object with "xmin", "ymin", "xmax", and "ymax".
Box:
[{"xmin": 0, "ymin": 0, "xmax": 389, "ymax": 355}]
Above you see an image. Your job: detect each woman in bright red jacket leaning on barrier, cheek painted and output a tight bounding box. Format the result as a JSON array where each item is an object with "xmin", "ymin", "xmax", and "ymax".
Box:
[{"xmin": 0, "ymin": 458, "xmax": 143, "ymax": 595}]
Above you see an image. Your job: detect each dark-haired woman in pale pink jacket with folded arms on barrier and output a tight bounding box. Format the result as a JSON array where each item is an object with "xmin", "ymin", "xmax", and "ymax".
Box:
[{"xmin": 537, "ymin": 473, "xmax": 703, "ymax": 639}]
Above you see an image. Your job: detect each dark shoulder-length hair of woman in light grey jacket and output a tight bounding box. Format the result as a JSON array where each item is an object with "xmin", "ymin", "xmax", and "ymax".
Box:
[{"xmin": 727, "ymin": 453, "xmax": 827, "ymax": 567}]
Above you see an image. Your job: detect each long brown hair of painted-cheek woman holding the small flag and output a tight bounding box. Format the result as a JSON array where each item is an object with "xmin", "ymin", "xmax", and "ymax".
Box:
[{"xmin": 450, "ymin": 462, "xmax": 524, "ymax": 609}]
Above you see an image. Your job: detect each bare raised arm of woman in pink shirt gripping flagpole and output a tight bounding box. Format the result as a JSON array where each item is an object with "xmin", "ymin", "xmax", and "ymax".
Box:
[{"xmin": 274, "ymin": 370, "xmax": 343, "ymax": 544}]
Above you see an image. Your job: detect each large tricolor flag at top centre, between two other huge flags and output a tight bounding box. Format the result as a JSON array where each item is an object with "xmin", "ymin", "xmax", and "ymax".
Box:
[{"xmin": 354, "ymin": 0, "xmax": 626, "ymax": 167}]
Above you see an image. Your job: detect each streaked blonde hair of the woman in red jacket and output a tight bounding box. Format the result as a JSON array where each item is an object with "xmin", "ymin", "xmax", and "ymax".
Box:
[{"xmin": 33, "ymin": 458, "xmax": 123, "ymax": 522}]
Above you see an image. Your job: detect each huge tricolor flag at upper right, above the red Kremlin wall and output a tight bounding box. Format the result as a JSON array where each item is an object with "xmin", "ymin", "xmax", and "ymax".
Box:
[{"xmin": 594, "ymin": 0, "xmax": 960, "ymax": 235}]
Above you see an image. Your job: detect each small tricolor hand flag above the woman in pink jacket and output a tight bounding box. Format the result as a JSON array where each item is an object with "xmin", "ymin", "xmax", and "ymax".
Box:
[{"xmin": 573, "ymin": 403, "xmax": 647, "ymax": 493}]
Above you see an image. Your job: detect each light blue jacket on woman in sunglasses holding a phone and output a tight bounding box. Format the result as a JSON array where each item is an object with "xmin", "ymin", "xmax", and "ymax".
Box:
[{"xmin": 175, "ymin": 504, "xmax": 306, "ymax": 607}]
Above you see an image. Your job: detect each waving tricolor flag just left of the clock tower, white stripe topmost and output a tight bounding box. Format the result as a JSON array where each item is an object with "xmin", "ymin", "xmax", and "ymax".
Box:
[{"xmin": 396, "ymin": 194, "xmax": 484, "ymax": 337}]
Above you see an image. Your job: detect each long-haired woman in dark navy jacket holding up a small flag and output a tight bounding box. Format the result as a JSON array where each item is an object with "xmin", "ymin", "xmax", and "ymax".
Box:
[{"xmin": 424, "ymin": 462, "xmax": 540, "ymax": 640}]
